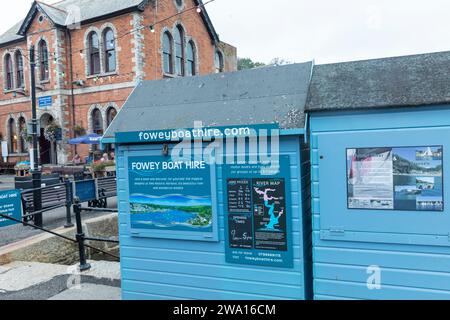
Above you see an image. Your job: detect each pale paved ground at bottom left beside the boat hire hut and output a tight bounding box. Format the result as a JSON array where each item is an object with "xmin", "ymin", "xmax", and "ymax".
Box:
[{"xmin": 0, "ymin": 261, "xmax": 121, "ymax": 301}]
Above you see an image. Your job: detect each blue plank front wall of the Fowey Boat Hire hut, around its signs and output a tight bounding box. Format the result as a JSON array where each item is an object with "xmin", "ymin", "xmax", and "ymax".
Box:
[{"xmin": 117, "ymin": 136, "xmax": 311, "ymax": 300}]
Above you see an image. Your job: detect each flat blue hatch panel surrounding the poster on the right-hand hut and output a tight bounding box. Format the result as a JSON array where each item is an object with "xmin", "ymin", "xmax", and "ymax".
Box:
[{"xmin": 316, "ymin": 127, "xmax": 450, "ymax": 240}]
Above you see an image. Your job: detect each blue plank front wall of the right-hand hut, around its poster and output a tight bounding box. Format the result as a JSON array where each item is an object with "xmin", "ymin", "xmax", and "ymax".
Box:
[{"xmin": 310, "ymin": 106, "xmax": 450, "ymax": 299}]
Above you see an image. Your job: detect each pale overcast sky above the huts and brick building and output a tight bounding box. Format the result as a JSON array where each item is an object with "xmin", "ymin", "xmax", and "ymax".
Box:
[{"xmin": 0, "ymin": 0, "xmax": 450, "ymax": 63}]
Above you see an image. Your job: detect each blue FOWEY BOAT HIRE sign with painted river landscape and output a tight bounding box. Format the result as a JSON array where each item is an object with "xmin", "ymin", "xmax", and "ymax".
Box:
[{"xmin": 128, "ymin": 156, "xmax": 214, "ymax": 238}]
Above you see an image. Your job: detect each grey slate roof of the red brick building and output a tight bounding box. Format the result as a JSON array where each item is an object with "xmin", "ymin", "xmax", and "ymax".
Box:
[{"xmin": 0, "ymin": 0, "xmax": 219, "ymax": 45}]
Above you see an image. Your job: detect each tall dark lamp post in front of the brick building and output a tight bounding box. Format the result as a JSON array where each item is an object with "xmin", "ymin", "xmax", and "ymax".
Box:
[{"xmin": 30, "ymin": 45, "xmax": 43, "ymax": 227}]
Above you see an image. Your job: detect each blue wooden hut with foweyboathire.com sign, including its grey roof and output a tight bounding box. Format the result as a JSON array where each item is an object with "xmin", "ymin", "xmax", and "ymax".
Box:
[{"xmin": 103, "ymin": 63, "xmax": 312, "ymax": 300}]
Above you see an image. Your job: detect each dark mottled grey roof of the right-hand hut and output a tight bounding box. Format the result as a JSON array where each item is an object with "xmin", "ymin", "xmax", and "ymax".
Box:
[{"xmin": 306, "ymin": 52, "xmax": 450, "ymax": 112}]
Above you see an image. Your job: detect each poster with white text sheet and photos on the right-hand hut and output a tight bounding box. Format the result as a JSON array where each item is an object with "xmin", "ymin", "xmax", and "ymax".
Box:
[{"xmin": 347, "ymin": 146, "xmax": 444, "ymax": 212}]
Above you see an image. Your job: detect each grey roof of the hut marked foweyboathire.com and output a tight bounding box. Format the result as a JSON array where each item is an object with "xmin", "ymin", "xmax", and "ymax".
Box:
[{"xmin": 104, "ymin": 63, "xmax": 312, "ymax": 138}]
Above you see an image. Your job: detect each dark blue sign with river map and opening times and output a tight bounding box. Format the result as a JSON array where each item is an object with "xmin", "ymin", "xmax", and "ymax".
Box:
[{"xmin": 223, "ymin": 156, "xmax": 293, "ymax": 268}]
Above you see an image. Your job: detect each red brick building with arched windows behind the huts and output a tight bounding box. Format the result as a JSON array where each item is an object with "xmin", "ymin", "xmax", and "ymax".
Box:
[{"xmin": 0, "ymin": 0, "xmax": 237, "ymax": 164}]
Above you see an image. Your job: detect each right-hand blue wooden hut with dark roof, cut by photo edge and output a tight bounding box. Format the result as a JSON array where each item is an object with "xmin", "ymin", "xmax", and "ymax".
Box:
[{"xmin": 306, "ymin": 52, "xmax": 450, "ymax": 299}]
